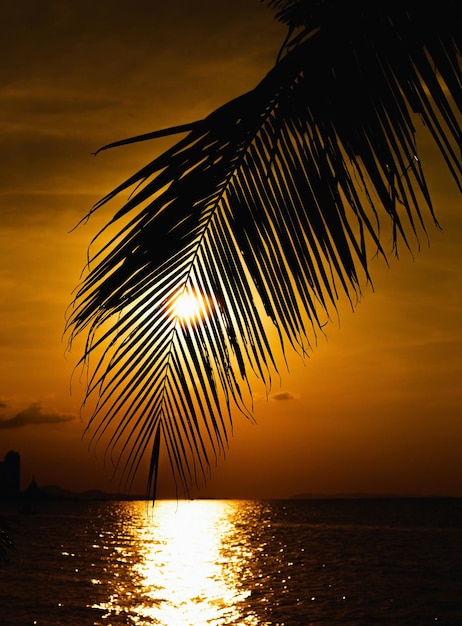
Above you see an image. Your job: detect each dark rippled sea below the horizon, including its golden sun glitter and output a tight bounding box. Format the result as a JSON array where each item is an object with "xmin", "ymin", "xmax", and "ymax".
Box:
[{"xmin": 0, "ymin": 499, "xmax": 462, "ymax": 626}]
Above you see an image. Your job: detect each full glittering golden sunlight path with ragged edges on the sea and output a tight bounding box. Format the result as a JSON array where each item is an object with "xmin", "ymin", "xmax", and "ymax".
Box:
[{"xmin": 92, "ymin": 500, "xmax": 259, "ymax": 626}]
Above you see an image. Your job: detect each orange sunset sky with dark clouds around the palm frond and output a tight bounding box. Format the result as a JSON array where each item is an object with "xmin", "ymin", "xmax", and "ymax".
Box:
[{"xmin": 0, "ymin": 0, "xmax": 462, "ymax": 497}]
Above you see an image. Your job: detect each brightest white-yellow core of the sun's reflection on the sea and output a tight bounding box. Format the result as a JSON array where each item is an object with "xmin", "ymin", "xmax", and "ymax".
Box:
[{"xmin": 137, "ymin": 500, "xmax": 249, "ymax": 624}]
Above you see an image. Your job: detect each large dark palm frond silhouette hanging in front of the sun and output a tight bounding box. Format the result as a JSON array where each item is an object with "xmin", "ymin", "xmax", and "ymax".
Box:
[{"xmin": 67, "ymin": 0, "xmax": 461, "ymax": 498}]
